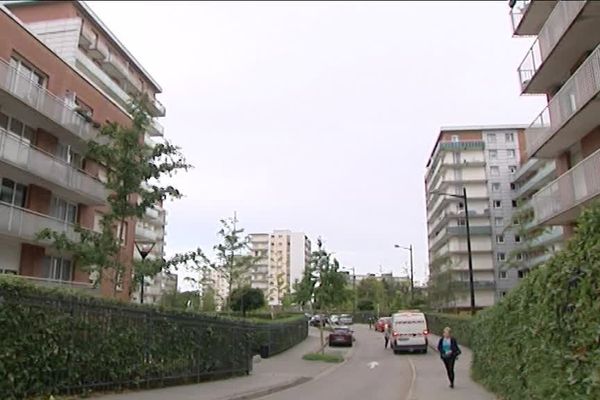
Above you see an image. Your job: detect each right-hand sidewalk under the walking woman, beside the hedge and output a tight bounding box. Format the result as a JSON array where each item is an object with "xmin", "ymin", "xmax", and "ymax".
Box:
[{"xmin": 415, "ymin": 334, "xmax": 497, "ymax": 400}]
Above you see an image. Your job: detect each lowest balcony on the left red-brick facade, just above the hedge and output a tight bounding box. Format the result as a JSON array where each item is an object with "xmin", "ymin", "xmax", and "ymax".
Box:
[{"xmin": 0, "ymin": 203, "xmax": 79, "ymax": 243}]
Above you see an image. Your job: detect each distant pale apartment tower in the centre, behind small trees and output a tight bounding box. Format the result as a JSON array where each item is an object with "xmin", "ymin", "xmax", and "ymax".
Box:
[{"xmin": 249, "ymin": 230, "xmax": 311, "ymax": 305}]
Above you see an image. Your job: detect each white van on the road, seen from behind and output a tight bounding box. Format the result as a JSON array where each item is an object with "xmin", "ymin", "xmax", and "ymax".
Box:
[{"xmin": 391, "ymin": 310, "xmax": 429, "ymax": 354}]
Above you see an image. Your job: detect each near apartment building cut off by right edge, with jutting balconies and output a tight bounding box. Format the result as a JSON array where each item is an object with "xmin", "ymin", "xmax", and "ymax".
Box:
[{"xmin": 509, "ymin": 1, "xmax": 600, "ymax": 237}]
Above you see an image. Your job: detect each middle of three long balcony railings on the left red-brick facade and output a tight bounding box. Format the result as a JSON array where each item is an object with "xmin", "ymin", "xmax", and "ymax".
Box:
[{"xmin": 0, "ymin": 128, "xmax": 108, "ymax": 204}]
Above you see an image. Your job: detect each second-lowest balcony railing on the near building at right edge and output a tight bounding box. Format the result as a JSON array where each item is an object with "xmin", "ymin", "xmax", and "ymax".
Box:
[{"xmin": 525, "ymin": 46, "xmax": 600, "ymax": 157}]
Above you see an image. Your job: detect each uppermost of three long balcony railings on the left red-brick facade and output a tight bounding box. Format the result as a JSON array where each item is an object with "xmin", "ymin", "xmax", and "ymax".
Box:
[{"xmin": 0, "ymin": 59, "xmax": 98, "ymax": 141}]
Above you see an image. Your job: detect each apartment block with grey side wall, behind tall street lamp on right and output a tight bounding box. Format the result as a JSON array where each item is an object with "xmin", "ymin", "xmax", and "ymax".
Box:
[{"xmin": 425, "ymin": 125, "xmax": 524, "ymax": 309}]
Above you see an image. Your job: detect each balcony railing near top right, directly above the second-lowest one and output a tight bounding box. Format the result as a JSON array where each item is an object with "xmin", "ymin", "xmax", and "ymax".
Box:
[{"xmin": 518, "ymin": 0, "xmax": 589, "ymax": 90}]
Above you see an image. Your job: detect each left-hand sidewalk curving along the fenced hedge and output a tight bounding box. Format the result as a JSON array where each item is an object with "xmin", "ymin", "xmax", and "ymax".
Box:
[{"xmin": 94, "ymin": 328, "xmax": 340, "ymax": 400}]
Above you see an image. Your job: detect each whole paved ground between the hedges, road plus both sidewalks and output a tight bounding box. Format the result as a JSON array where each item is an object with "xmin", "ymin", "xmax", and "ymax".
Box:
[{"xmin": 97, "ymin": 325, "xmax": 496, "ymax": 400}]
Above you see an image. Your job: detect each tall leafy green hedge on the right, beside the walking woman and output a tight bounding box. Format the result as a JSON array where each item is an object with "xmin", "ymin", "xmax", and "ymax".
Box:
[{"xmin": 472, "ymin": 204, "xmax": 600, "ymax": 400}]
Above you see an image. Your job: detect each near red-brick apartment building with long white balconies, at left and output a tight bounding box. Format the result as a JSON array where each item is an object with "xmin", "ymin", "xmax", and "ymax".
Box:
[{"xmin": 0, "ymin": 1, "xmax": 165, "ymax": 299}]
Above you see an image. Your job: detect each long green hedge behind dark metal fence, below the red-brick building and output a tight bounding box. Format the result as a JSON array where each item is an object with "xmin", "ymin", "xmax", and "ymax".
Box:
[{"xmin": 0, "ymin": 277, "xmax": 308, "ymax": 400}]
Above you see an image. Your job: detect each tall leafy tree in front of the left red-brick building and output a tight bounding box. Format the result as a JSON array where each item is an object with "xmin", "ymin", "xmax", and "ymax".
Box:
[{"xmin": 38, "ymin": 99, "xmax": 196, "ymax": 293}]
